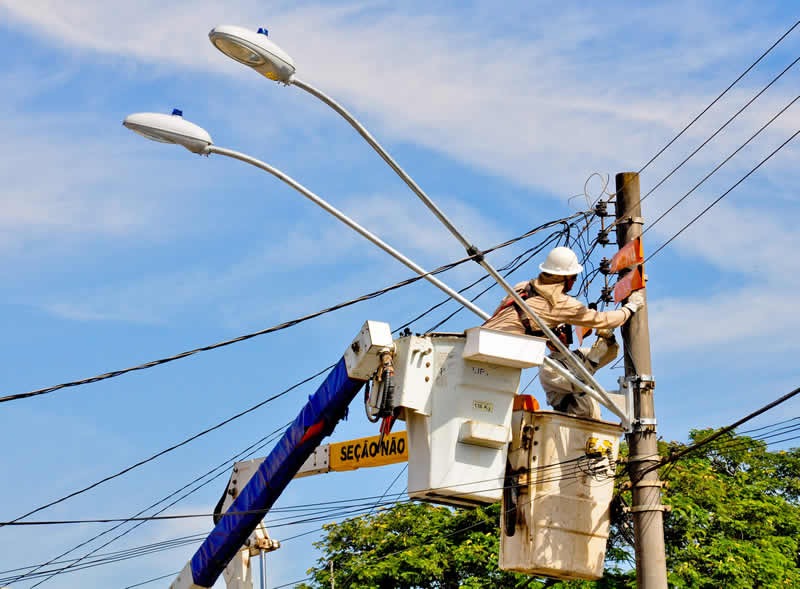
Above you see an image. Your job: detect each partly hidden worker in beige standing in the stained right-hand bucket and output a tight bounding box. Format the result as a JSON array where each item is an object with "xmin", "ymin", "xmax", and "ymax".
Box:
[{"xmin": 539, "ymin": 326, "xmax": 619, "ymax": 419}]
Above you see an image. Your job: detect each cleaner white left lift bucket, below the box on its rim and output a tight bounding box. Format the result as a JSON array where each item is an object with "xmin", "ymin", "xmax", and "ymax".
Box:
[{"xmin": 395, "ymin": 334, "xmax": 522, "ymax": 505}]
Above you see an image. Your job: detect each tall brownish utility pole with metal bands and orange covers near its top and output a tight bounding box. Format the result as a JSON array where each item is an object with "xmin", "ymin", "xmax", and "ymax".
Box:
[{"xmin": 616, "ymin": 172, "xmax": 667, "ymax": 589}]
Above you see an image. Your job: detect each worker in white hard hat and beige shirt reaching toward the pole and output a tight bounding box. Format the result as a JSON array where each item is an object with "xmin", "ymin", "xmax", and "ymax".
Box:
[{"xmin": 483, "ymin": 247, "xmax": 644, "ymax": 337}]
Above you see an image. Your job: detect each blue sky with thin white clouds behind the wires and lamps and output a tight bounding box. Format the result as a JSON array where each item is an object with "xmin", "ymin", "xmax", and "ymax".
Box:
[{"xmin": 0, "ymin": 0, "xmax": 800, "ymax": 588}]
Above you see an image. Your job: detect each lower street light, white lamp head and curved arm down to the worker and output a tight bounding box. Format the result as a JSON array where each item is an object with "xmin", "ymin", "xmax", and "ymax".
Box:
[{"xmin": 122, "ymin": 109, "xmax": 490, "ymax": 320}]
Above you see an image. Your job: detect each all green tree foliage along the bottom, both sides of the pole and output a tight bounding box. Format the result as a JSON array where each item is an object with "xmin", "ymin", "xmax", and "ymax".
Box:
[{"xmin": 300, "ymin": 430, "xmax": 800, "ymax": 589}]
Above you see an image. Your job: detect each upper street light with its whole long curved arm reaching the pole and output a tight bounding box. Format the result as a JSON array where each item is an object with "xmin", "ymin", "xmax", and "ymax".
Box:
[{"xmin": 208, "ymin": 25, "xmax": 629, "ymax": 418}]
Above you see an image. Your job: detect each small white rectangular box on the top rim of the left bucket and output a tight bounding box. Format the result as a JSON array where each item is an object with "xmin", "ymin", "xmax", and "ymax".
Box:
[{"xmin": 464, "ymin": 327, "xmax": 547, "ymax": 368}]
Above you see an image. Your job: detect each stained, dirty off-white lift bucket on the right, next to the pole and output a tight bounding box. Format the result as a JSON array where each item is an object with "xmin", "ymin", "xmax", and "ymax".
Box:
[{"xmin": 500, "ymin": 411, "xmax": 623, "ymax": 579}]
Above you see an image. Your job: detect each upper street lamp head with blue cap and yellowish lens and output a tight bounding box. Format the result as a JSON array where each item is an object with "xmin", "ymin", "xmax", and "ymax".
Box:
[{"xmin": 208, "ymin": 25, "xmax": 295, "ymax": 84}]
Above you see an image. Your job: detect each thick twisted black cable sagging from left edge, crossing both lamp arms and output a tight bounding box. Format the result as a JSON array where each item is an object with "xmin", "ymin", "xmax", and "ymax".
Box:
[{"xmin": 0, "ymin": 213, "xmax": 583, "ymax": 403}]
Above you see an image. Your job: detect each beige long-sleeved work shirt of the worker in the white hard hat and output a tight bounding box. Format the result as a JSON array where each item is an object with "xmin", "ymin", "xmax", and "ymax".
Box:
[{"xmin": 483, "ymin": 275, "xmax": 632, "ymax": 334}]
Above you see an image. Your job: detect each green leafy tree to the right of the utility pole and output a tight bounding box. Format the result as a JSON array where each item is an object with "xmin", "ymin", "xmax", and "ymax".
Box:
[{"xmin": 662, "ymin": 430, "xmax": 800, "ymax": 589}]
